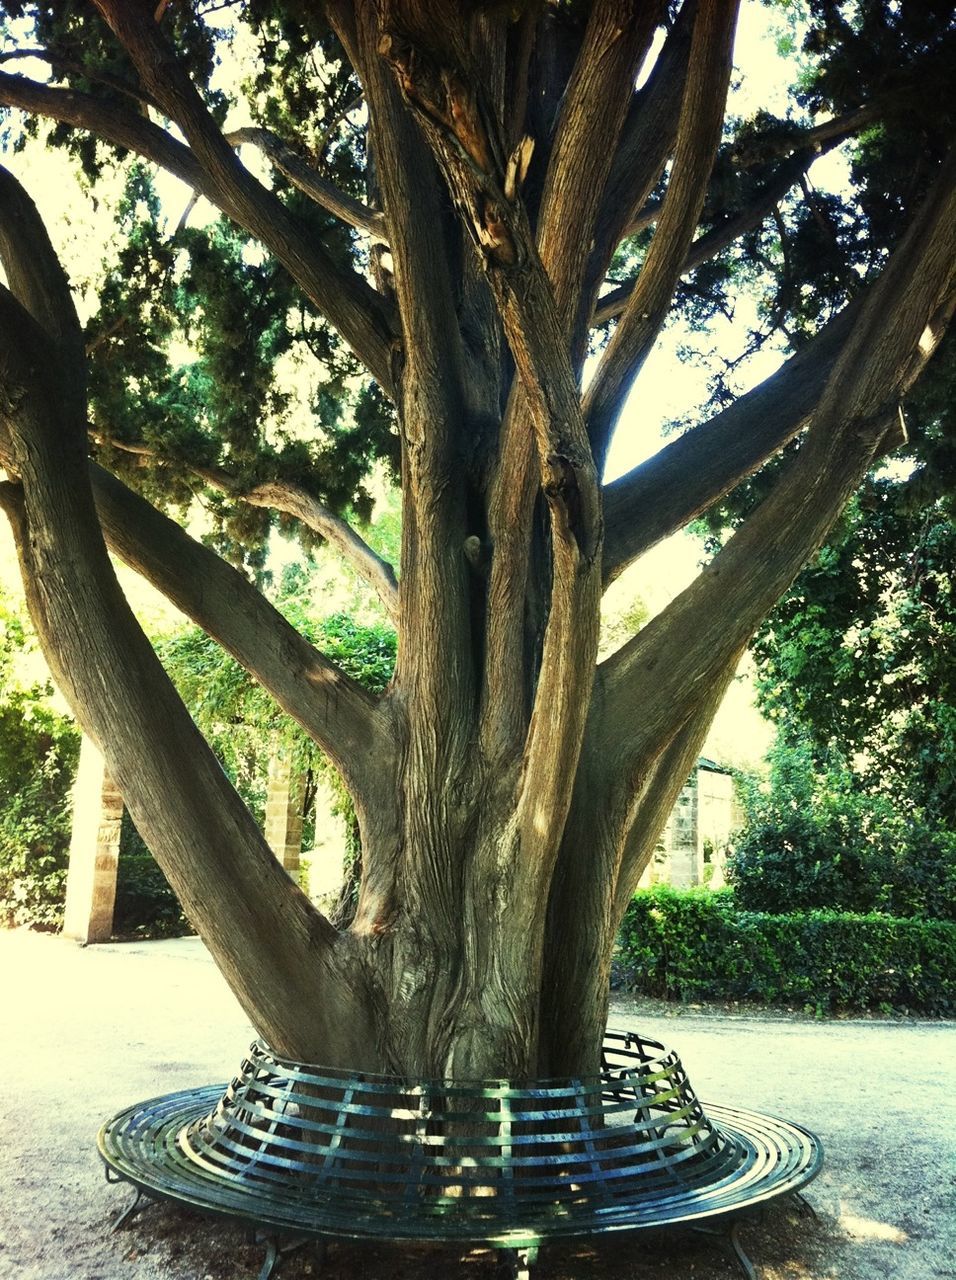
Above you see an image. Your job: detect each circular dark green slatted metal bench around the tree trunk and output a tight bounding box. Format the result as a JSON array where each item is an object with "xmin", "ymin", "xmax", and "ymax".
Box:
[{"xmin": 99, "ymin": 1032, "xmax": 822, "ymax": 1280}]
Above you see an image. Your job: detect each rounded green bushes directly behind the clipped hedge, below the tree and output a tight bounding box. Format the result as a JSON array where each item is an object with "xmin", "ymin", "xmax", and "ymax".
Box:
[{"xmin": 727, "ymin": 742, "xmax": 956, "ymax": 920}]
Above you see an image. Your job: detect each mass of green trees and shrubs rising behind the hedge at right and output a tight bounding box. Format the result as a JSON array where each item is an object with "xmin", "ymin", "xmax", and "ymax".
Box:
[{"xmin": 729, "ymin": 481, "xmax": 956, "ymax": 919}]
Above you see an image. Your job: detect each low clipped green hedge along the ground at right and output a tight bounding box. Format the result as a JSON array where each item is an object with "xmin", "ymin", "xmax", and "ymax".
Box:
[{"xmin": 616, "ymin": 887, "xmax": 956, "ymax": 1014}]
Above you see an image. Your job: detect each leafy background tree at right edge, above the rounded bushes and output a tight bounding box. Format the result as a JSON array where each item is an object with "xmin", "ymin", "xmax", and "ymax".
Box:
[{"xmin": 755, "ymin": 481, "xmax": 956, "ymax": 831}]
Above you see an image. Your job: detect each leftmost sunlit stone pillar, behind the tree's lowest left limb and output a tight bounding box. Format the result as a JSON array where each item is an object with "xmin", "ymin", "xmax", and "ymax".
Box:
[{"xmin": 63, "ymin": 737, "xmax": 123, "ymax": 942}]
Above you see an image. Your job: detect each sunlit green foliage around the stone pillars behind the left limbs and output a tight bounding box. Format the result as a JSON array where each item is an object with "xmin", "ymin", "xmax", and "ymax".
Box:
[{"xmin": 0, "ymin": 550, "xmax": 395, "ymax": 937}]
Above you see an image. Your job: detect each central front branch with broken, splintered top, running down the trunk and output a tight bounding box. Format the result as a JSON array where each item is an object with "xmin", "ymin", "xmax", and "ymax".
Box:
[{"xmin": 381, "ymin": 7, "xmax": 601, "ymax": 920}]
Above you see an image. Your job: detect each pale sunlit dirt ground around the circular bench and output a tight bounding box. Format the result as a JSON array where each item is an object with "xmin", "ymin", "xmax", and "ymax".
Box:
[{"xmin": 0, "ymin": 931, "xmax": 956, "ymax": 1280}]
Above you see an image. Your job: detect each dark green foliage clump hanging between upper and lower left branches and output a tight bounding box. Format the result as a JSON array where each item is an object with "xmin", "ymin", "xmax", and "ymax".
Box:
[{"xmin": 86, "ymin": 163, "xmax": 397, "ymax": 571}]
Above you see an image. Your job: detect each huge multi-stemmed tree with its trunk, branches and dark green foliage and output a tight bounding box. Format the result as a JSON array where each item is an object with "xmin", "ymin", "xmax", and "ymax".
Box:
[{"xmin": 0, "ymin": 0, "xmax": 956, "ymax": 1078}]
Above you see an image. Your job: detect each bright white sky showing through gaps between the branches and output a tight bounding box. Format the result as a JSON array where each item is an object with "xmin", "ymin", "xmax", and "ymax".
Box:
[{"xmin": 0, "ymin": 0, "xmax": 847, "ymax": 763}]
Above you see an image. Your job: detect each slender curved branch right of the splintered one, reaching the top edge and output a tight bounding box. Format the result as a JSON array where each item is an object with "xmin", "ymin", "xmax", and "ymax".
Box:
[{"xmin": 585, "ymin": 0, "xmax": 737, "ymax": 458}]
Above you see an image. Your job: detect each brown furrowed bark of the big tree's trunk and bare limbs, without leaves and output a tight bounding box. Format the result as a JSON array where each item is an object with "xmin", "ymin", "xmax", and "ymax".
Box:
[{"xmin": 0, "ymin": 0, "xmax": 956, "ymax": 1078}]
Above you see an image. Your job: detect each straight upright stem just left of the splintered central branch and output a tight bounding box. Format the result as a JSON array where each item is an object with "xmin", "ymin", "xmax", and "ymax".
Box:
[{"xmin": 348, "ymin": 3, "xmax": 482, "ymax": 752}]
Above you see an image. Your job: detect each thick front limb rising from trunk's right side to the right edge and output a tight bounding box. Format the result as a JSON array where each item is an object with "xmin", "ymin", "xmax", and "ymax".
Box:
[{"xmin": 604, "ymin": 151, "xmax": 956, "ymax": 760}]
